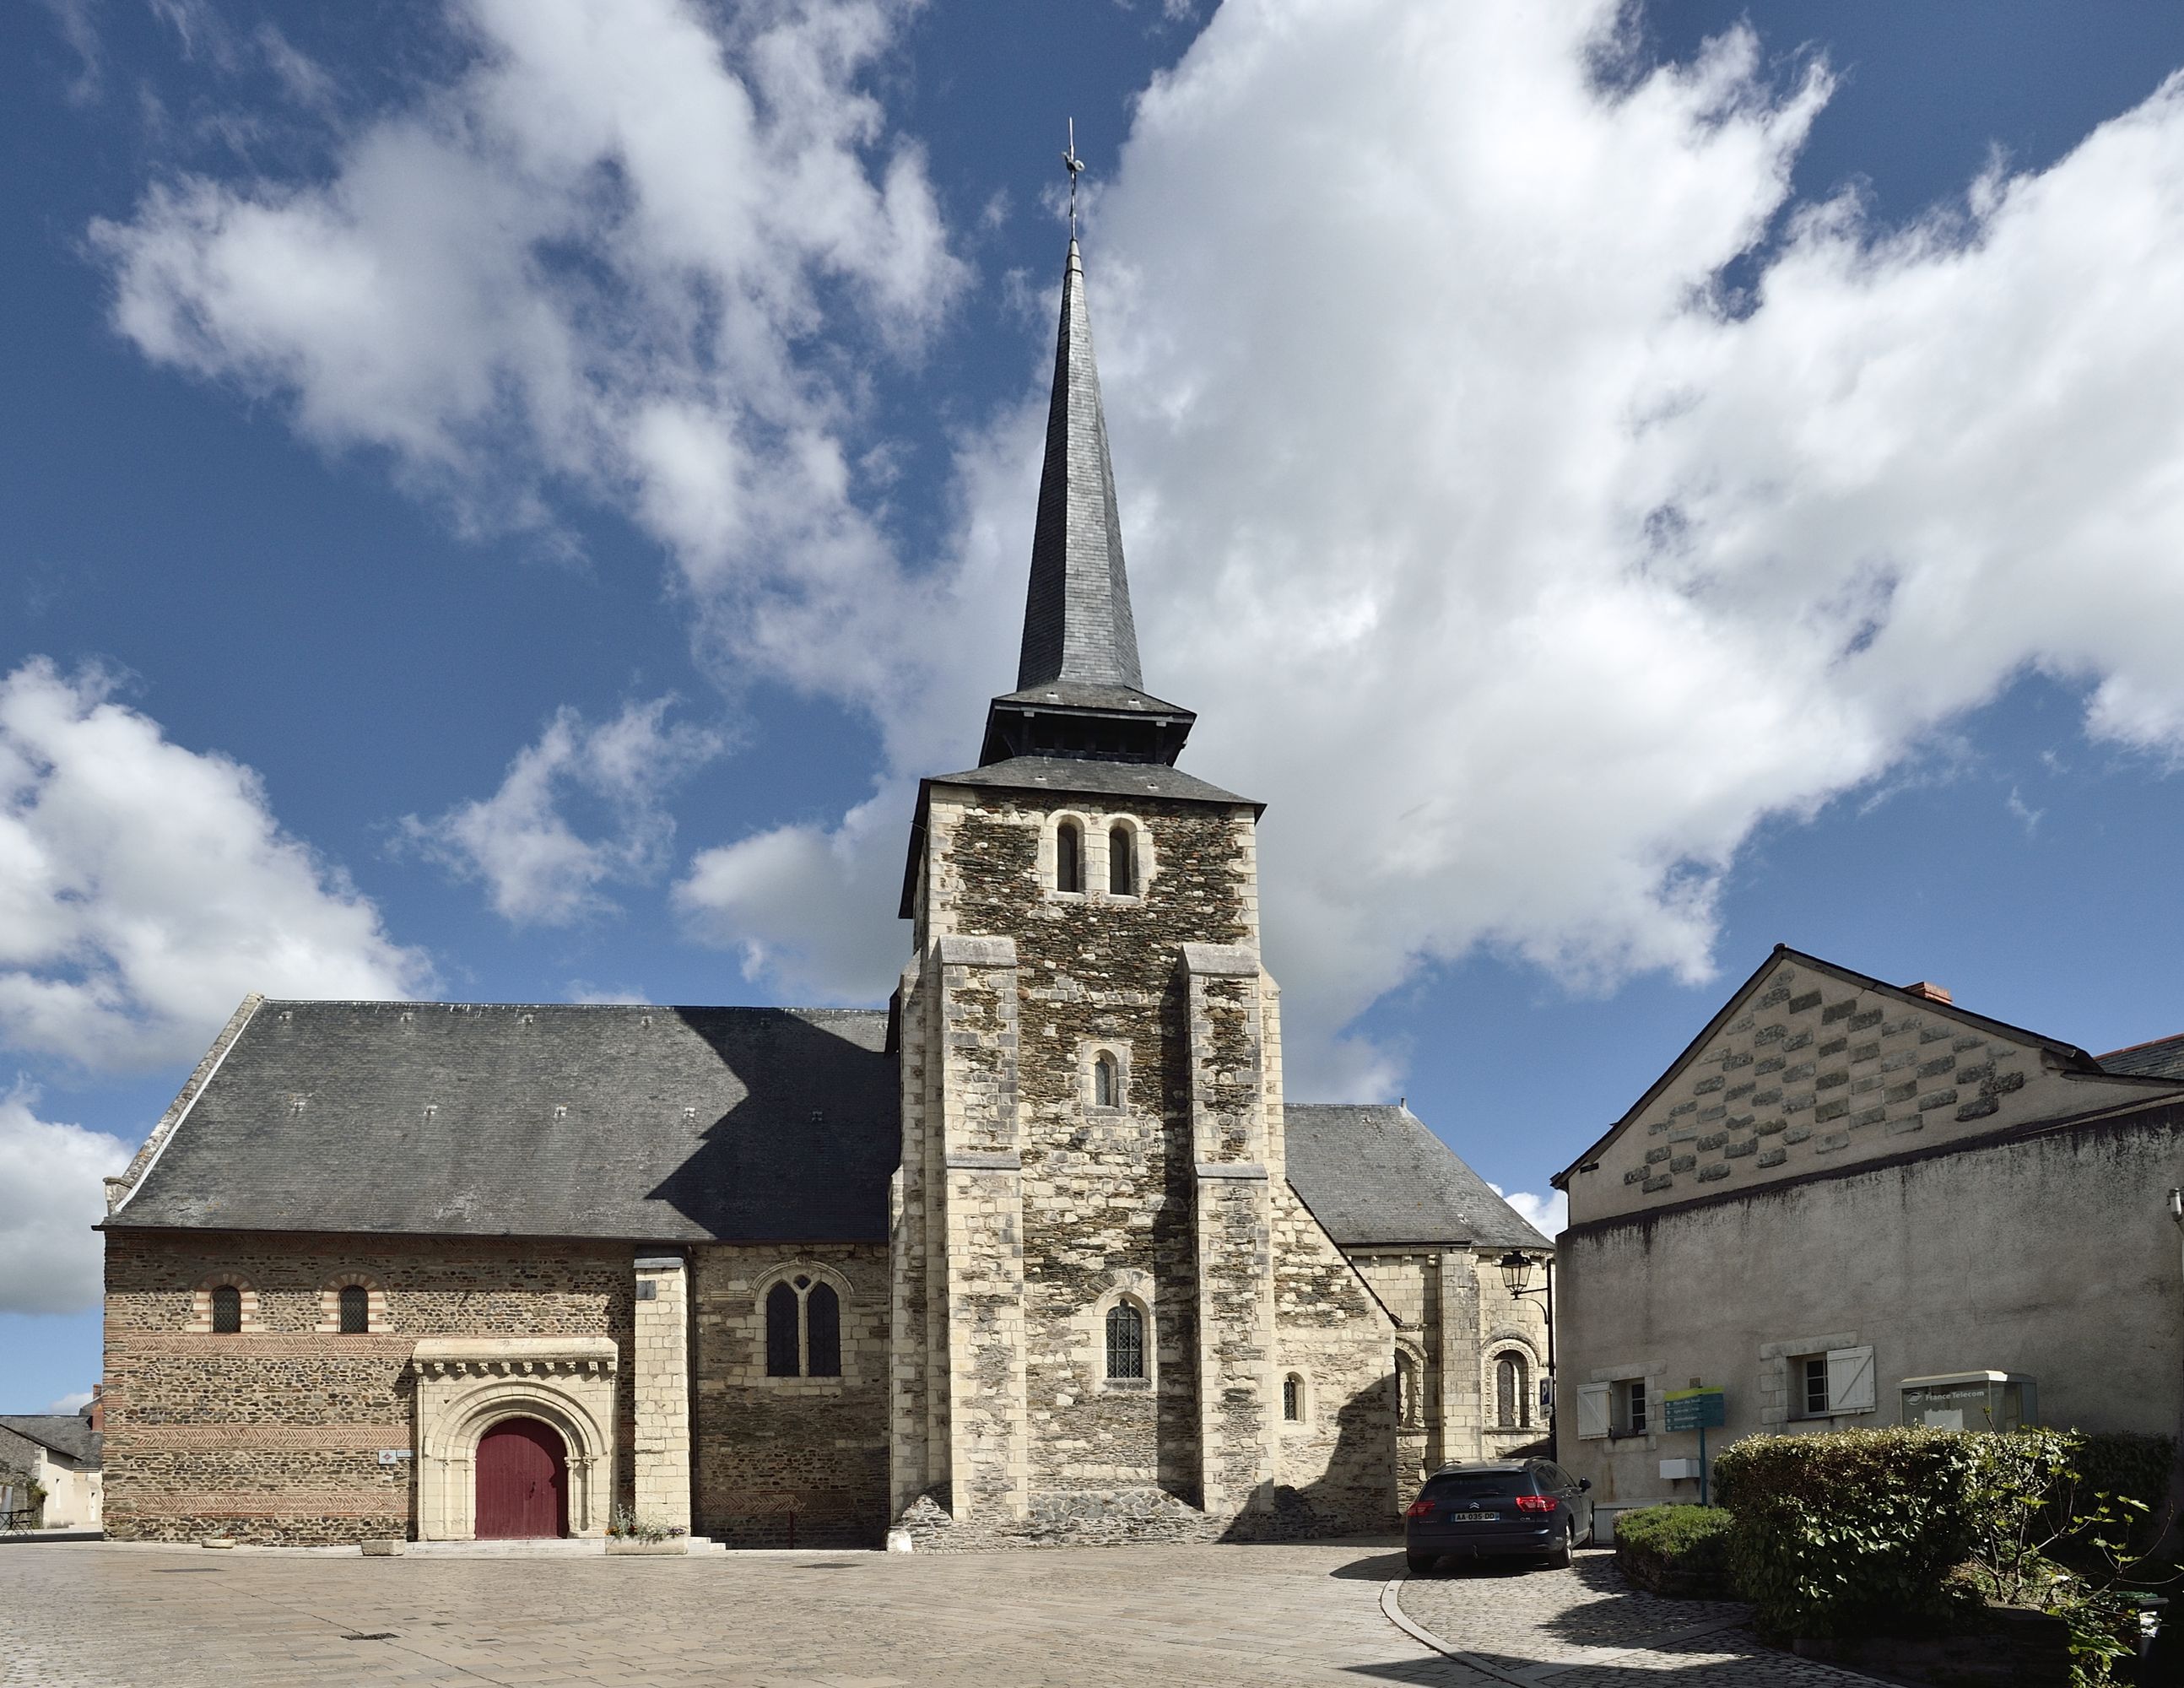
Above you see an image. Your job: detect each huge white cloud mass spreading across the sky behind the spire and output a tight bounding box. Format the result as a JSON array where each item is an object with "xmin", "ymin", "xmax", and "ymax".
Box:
[{"xmin": 100, "ymin": 0, "xmax": 2184, "ymax": 1094}]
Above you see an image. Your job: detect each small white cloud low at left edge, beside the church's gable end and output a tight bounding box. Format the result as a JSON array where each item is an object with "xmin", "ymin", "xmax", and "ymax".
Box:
[{"xmin": 0, "ymin": 1085, "xmax": 129, "ymax": 1318}]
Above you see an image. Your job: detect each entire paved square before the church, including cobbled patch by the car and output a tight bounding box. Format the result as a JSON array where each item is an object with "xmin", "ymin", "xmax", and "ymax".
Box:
[{"xmin": 0, "ymin": 1542, "xmax": 1863, "ymax": 1688}]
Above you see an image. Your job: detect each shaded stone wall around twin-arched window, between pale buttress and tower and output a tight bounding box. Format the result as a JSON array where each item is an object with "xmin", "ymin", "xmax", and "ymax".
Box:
[{"xmin": 690, "ymin": 1242, "xmax": 889, "ymax": 1546}]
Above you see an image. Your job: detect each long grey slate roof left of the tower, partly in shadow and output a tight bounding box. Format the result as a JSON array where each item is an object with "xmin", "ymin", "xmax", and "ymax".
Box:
[{"xmin": 107, "ymin": 1003, "xmax": 902, "ymax": 1242}]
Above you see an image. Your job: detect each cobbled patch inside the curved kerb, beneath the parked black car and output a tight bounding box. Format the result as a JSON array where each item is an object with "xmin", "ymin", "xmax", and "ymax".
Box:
[{"xmin": 1397, "ymin": 1550, "xmax": 1872, "ymax": 1688}]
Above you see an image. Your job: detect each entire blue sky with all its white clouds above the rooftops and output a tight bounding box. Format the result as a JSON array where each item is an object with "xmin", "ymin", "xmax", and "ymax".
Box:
[{"xmin": 0, "ymin": 0, "xmax": 2184, "ymax": 1410}]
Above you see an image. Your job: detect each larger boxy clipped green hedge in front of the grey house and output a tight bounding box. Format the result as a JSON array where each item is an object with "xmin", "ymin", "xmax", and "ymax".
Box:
[{"xmin": 1711, "ymin": 1428, "xmax": 1975, "ymax": 1636}]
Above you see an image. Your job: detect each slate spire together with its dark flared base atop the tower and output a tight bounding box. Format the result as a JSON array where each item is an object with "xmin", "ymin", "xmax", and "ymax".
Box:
[{"xmin": 978, "ymin": 238, "xmax": 1195, "ymax": 766}]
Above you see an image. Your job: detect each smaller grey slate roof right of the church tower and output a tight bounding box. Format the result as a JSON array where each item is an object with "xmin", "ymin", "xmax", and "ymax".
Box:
[{"xmin": 1282, "ymin": 1103, "xmax": 1553, "ymax": 1249}]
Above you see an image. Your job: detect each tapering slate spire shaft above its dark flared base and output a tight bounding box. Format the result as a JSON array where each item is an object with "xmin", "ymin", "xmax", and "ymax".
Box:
[{"xmin": 1015, "ymin": 238, "xmax": 1144, "ymax": 690}]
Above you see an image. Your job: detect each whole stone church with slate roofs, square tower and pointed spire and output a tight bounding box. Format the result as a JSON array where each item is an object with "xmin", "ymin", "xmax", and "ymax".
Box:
[{"xmin": 103, "ymin": 241, "xmax": 1550, "ymax": 1553}]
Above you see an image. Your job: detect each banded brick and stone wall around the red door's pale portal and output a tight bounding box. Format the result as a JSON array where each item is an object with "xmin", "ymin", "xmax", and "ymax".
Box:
[{"xmin": 105, "ymin": 1230, "xmax": 634, "ymax": 1544}]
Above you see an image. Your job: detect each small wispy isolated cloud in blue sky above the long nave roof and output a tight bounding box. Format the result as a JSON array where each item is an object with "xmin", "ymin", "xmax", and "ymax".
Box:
[{"xmin": 402, "ymin": 696, "xmax": 725, "ymax": 926}]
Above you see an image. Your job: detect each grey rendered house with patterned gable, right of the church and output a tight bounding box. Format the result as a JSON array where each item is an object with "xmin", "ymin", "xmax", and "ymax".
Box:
[{"xmin": 1555, "ymin": 948, "xmax": 2184, "ymax": 1513}]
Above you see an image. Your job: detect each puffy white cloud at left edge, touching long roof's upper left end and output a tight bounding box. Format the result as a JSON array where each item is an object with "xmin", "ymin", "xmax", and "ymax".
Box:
[{"xmin": 0, "ymin": 659, "xmax": 430, "ymax": 1068}]
